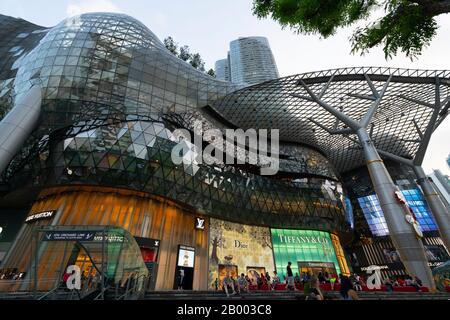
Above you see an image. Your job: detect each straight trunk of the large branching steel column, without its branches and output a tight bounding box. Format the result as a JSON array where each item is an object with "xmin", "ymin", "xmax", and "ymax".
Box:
[{"xmin": 357, "ymin": 128, "xmax": 436, "ymax": 290}]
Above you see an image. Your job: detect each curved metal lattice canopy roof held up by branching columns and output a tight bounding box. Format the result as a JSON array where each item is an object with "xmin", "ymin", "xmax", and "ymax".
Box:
[{"xmin": 212, "ymin": 67, "xmax": 450, "ymax": 172}]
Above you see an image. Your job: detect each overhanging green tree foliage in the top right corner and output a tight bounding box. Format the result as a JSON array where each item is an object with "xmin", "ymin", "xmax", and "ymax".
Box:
[{"xmin": 253, "ymin": 0, "xmax": 450, "ymax": 58}]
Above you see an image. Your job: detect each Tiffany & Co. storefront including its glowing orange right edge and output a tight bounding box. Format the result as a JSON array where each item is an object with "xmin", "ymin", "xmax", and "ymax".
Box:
[{"xmin": 271, "ymin": 229, "xmax": 349, "ymax": 280}]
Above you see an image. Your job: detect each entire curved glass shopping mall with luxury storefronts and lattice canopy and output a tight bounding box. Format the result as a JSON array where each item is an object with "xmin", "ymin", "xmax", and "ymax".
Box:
[{"xmin": 0, "ymin": 13, "xmax": 450, "ymax": 290}]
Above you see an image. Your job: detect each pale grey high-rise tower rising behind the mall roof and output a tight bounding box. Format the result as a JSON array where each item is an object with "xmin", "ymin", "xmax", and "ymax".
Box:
[{"xmin": 216, "ymin": 37, "xmax": 279, "ymax": 85}]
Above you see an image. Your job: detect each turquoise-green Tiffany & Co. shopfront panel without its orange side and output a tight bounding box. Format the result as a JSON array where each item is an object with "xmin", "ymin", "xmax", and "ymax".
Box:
[{"xmin": 271, "ymin": 229, "xmax": 341, "ymax": 279}]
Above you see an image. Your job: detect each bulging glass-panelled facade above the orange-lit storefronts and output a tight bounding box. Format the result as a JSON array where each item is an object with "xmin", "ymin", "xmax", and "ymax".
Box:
[{"xmin": 2, "ymin": 13, "xmax": 347, "ymax": 235}]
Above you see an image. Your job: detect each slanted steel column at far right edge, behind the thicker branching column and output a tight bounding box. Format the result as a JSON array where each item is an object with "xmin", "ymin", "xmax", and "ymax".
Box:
[{"xmin": 413, "ymin": 166, "xmax": 450, "ymax": 252}]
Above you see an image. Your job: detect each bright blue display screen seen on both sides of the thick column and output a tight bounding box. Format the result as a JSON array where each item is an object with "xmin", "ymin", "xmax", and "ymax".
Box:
[{"xmin": 358, "ymin": 188, "xmax": 437, "ymax": 236}]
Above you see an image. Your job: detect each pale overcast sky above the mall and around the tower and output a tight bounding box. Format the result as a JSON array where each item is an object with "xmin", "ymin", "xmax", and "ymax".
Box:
[{"xmin": 0, "ymin": 0, "xmax": 450, "ymax": 175}]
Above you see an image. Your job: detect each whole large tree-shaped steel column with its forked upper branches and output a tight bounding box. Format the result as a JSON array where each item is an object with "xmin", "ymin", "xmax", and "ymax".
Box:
[{"xmin": 300, "ymin": 75, "xmax": 438, "ymax": 291}]
